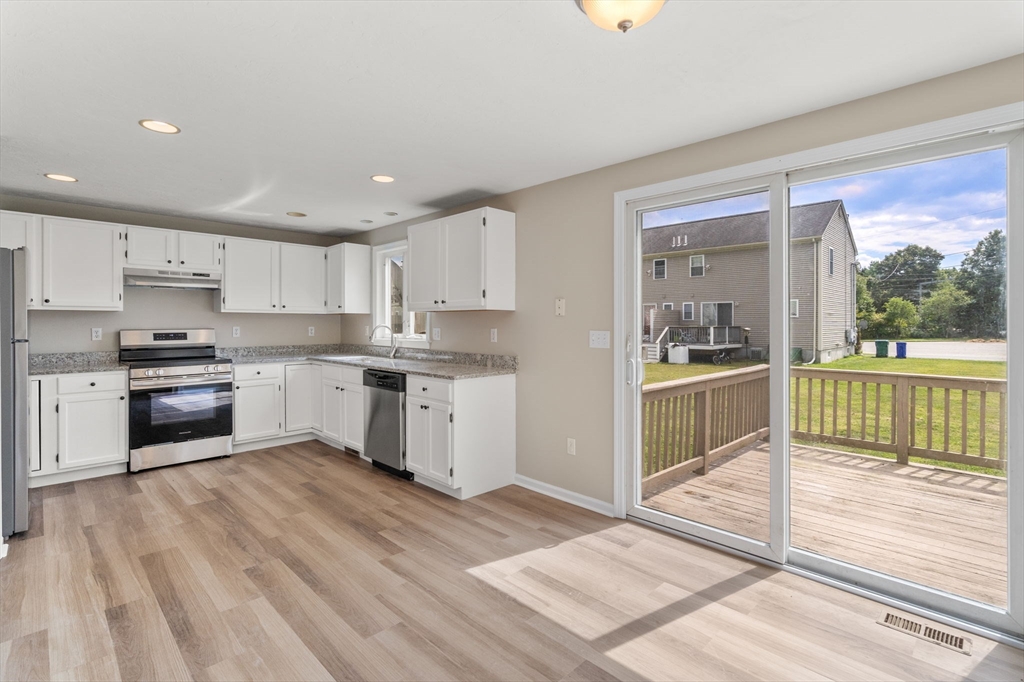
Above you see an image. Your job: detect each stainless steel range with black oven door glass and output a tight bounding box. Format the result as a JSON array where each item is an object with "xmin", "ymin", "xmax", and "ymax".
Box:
[{"xmin": 120, "ymin": 329, "xmax": 232, "ymax": 471}]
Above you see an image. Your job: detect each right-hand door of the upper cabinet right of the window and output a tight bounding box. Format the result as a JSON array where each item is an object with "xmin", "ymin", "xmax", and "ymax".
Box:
[{"xmin": 441, "ymin": 211, "xmax": 484, "ymax": 310}]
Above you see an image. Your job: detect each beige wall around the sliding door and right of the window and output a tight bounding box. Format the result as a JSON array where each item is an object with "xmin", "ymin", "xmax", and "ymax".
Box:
[{"xmin": 342, "ymin": 55, "xmax": 1024, "ymax": 502}]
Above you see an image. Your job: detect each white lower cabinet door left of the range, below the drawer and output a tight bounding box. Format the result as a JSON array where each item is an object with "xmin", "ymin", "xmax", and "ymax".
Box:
[{"xmin": 57, "ymin": 391, "xmax": 128, "ymax": 469}]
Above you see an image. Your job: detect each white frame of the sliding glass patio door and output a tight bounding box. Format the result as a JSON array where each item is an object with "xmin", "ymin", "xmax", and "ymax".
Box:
[{"xmin": 612, "ymin": 102, "xmax": 1024, "ymax": 641}]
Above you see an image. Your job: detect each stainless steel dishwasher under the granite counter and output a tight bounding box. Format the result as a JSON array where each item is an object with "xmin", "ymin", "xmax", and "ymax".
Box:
[{"xmin": 362, "ymin": 370, "xmax": 413, "ymax": 479}]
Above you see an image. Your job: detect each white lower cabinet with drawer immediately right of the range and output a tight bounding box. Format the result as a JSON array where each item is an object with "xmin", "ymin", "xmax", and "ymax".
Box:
[{"xmin": 233, "ymin": 365, "xmax": 284, "ymax": 442}]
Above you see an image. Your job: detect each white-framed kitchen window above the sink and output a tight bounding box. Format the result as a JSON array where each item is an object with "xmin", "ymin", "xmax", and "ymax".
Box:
[{"xmin": 372, "ymin": 242, "xmax": 430, "ymax": 348}]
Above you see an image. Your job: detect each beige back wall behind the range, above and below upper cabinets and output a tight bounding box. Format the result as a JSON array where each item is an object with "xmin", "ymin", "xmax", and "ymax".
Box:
[{"xmin": 0, "ymin": 195, "xmax": 341, "ymax": 353}]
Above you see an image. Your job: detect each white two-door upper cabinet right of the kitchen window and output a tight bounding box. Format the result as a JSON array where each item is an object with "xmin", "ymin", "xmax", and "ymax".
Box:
[{"xmin": 409, "ymin": 208, "xmax": 515, "ymax": 311}]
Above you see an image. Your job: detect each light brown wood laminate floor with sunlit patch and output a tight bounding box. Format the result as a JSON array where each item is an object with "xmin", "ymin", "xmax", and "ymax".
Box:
[{"xmin": 0, "ymin": 441, "xmax": 1024, "ymax": 682}]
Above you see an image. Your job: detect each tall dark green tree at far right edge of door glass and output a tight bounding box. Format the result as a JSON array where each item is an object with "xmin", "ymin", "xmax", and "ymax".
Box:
[{"xmin": 956, "ymin": 229, "xmax": 1007, "ymax": 337}]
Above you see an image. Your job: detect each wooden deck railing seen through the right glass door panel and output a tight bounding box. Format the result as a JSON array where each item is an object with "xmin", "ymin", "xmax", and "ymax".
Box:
[{"xmin": 790, "ymin": 368, "xmax": 1007, "ymax": 470}]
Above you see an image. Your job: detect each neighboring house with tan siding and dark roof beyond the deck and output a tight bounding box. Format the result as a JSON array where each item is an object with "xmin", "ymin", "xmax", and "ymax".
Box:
[{"xmin": 642, "ymin": 200, "xmax": 857, "ymax": 363}]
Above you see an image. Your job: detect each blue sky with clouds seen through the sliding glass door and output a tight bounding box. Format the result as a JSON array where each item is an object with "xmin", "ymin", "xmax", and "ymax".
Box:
[{"xmin": 644, "ymin": 150, "xmax": 1007, "ymax": 267}]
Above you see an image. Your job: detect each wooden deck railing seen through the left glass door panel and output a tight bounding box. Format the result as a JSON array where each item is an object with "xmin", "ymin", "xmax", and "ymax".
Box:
[{"xmin": 641, "ymin": 365, "xmax": 768, "ymax": 489}]
